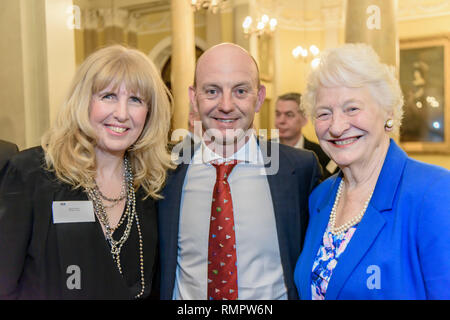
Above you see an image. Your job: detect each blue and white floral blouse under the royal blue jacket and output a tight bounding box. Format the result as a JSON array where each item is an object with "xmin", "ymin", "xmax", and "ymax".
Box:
[{"xmin": 311, "ymin": 224, "xmax": 358, "ymax": 300}]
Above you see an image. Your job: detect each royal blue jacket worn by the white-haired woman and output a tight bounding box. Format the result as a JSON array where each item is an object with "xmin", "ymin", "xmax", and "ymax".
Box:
[{"xmin": 294, "ymin": 140, "xmax": 450, "ymax": 300}]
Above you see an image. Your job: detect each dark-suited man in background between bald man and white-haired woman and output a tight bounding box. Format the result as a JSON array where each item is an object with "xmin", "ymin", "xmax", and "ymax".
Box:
[{"xmin": 275, "ymin": 92, "xmax": 337, "ymax": 178}]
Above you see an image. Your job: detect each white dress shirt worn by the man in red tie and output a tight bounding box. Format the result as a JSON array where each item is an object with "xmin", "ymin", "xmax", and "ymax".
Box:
[{"xmin": 173, "ymin": 135, "xmax": 287, "ymax": 300}]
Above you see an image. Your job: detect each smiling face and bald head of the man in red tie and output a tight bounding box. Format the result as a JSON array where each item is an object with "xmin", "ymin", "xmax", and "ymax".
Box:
[{"xmin": 189, "ymin": 44, "xmax": 265, "ymax": 145}]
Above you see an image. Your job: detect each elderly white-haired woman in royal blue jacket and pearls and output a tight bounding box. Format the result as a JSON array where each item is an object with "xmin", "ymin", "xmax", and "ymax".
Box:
[{"xmin": 295, "ymin": 44, "xmax": 450, "ymax": 300}]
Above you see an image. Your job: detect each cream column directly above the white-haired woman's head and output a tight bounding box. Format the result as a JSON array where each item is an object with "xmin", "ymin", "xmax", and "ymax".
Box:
[{"xmin": 345, "ymin": 0, "xmax": 399, "ymax": 67}]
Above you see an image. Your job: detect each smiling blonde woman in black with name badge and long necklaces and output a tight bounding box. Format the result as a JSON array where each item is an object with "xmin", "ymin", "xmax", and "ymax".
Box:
[{"xmin": 0, "ymin": 46, "xmax": 172, "ymax": 299}]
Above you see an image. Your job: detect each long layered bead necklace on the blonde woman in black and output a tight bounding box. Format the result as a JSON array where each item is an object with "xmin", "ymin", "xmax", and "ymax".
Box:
[{"xmin": 86, "ymin": 157, "xmax": 145, "ymax": 299}]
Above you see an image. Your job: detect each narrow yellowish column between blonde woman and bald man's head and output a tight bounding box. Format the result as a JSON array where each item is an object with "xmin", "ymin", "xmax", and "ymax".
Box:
[{"xmin": 170, "ymin": 1, "xmax": 195, "ymax": 130}]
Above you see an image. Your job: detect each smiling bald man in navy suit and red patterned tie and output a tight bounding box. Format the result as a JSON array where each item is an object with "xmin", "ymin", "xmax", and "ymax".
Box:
[{"xmin": 159, "ymin": 43, "xmax": 320, "ymax": 300}]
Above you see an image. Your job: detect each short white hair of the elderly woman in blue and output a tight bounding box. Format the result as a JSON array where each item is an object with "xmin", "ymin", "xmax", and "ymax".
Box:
[{"xmin": 302, "ymin": 43, "xmax": 403, "ymax": 133}]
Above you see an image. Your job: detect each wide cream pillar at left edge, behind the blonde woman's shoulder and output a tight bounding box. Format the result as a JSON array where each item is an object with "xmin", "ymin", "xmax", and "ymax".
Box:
[{"xmin": 0, "ymin": 0, "xmax": 75, "ymax": 149}]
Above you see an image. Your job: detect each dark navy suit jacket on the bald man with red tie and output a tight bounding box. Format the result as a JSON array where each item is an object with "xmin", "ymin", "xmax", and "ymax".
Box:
[{"xmin": 158, "ymin": 139, "xmax": 320, "ymax": 300}]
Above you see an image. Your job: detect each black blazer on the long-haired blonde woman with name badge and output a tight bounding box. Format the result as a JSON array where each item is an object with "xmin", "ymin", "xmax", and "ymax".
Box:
[{"xmin": 0, "ymin": 147, "xmax": 157, "ymax": 300}]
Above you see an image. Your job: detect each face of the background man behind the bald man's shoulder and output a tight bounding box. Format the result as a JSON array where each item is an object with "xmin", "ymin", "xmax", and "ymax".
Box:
[{"xmin": 275, "ymin": 100, "xmax": 308, "ymax": 139}]
